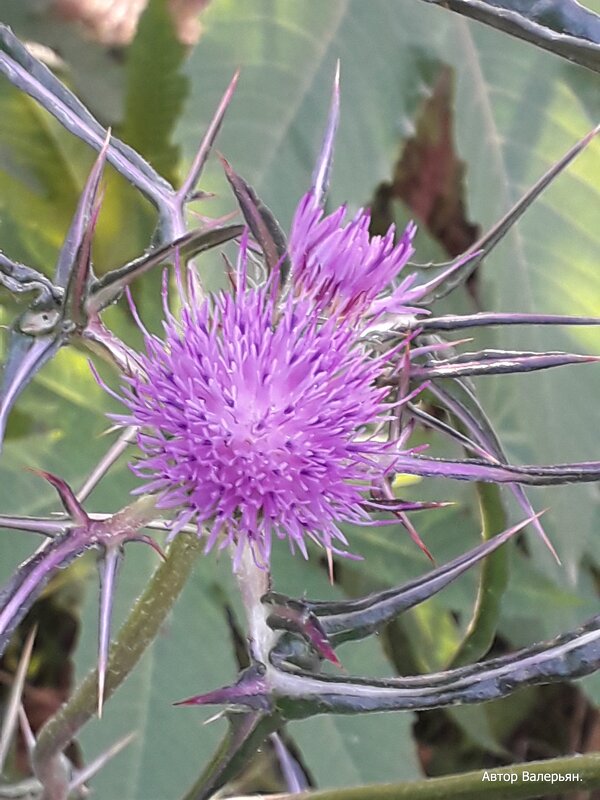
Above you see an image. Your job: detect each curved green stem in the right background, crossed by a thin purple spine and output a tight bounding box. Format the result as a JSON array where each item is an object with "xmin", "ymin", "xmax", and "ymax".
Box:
[{"xmin": 448, "ymin": 483, "xmax": 508, "ymax": 668}]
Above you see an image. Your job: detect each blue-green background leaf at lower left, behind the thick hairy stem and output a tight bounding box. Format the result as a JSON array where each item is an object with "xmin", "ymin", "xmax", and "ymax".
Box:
[{"xmin": 73, "ymin": 545, "xmax": 236, "ymax": 800}]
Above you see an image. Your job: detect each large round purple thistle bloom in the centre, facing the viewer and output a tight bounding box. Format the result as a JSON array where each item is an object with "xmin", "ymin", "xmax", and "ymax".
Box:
[{"xmin": 111, "ymin": 241, "xmax": 408, "ymax": 567}]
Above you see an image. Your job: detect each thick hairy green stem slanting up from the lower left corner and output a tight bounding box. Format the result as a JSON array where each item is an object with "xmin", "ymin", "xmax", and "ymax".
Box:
[{"xmin": 33, "ymin": 533, "xmax": 202, "ymax": 800}]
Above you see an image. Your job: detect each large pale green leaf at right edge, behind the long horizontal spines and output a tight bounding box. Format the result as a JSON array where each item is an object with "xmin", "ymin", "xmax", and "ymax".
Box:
[{"xmin": 452, "ymin": 20, "xmax": 600, "ymax": 581}]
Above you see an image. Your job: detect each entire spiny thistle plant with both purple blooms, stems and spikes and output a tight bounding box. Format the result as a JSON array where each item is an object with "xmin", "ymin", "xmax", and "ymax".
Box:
[{"xmin": 0, "ymin": 6, "xmax": 600, "ymax": 800}]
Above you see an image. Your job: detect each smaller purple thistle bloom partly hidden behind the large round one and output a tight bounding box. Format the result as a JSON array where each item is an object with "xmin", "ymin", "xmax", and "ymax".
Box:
[{"xmin": 289, "ymin": 190, "xmax": 424, "ymax": 316}]
